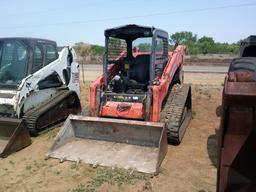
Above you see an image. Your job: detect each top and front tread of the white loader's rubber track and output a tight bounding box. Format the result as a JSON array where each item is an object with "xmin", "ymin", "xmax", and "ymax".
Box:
[{"xmin": 23, "ymin": 90, "xmax": 69, "ymax": 135}]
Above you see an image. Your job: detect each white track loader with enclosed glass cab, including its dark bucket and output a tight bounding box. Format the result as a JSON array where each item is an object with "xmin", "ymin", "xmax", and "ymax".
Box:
[{"xmin": 0, "ymin": 38, "xmax": 81, "ymax": 157}]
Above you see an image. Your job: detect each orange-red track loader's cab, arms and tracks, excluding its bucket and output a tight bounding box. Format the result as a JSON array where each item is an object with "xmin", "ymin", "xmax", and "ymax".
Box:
[{"xmin": 90, "ymin": 25, "xmax": 191, "ymax": 143}]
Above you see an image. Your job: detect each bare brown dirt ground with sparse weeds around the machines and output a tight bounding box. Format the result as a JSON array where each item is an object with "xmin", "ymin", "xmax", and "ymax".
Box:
[{"xmin": 0, "ymin": 73, "xmax": 224, "ymax": 192}]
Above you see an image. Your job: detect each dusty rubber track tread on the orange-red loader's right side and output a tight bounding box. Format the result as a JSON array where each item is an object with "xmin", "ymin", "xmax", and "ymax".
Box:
[{"xmin": 161, "ymin": 84, "xmax": 190, "ymax": 144}]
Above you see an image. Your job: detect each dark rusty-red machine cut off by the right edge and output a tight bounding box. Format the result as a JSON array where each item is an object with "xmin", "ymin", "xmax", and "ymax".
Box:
[{"xmin": 217, "ymin": 36, "xmax": 256, "ymax": 192}]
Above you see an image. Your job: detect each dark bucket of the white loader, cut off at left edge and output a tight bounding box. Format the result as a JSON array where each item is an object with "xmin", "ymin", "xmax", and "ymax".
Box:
[{"xmin": 0, "ymin": 118, "xmax": 31, "ymax": 157}]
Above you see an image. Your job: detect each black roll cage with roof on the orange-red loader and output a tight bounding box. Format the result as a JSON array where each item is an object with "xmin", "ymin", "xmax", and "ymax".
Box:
[{"xmin": 103, "ymin": 25, "xmax": 168, "ymax": 87}]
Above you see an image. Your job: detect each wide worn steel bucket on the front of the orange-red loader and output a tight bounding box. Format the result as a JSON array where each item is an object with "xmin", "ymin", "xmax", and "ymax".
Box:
[{"xmin": 46, "ymin": 115, "xmax": 168, "ymax": 173}]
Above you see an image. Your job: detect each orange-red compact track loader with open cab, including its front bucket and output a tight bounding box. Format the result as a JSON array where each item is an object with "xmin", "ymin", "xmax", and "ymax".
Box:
[{"xmin": 46, "ymin": 25, "xmax": 191, "ymax": 173}]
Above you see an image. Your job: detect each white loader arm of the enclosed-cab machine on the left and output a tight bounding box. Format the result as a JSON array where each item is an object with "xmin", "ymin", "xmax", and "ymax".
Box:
[{"xmin": 14, "ymin": 47, "xmax": 80, "ymax": 118}]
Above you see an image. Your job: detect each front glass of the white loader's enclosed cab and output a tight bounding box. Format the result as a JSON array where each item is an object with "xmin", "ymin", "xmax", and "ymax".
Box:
[{"xmin": 0, "ymin": 40, "xmax": 28, "ymax": 88}]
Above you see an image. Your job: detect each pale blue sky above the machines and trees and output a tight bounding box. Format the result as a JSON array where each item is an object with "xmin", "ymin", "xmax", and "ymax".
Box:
[{"xmin": 0, "ymin": 0, "xmax": 256, "ymax": 45}]
